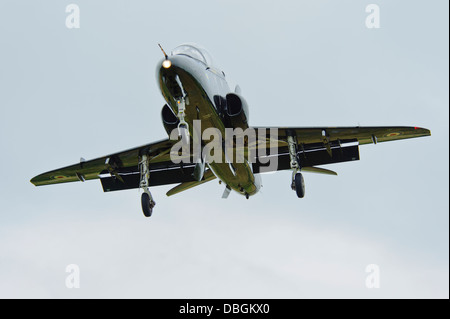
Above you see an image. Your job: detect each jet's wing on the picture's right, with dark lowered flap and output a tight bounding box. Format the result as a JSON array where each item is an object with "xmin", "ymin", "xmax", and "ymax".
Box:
[{"xmin": 253, "ymin": 126, "xmax": 431, "ymax": 173}]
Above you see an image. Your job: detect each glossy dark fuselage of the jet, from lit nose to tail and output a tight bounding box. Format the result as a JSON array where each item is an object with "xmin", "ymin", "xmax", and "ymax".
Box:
[{"xmin": 156, "ymin": 46, "xmax": 261, "ymax": 196}]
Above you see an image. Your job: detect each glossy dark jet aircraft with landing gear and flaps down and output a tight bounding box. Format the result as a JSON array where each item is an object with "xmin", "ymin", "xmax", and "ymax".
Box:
[{"xmin": 31, "ymin": 44, "xmax": 430, "ymax": 217}]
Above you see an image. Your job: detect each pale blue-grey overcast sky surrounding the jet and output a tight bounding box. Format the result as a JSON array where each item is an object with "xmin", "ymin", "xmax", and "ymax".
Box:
[{"xmin": 0, "ymin": 0, "xmax": 449, "ymax": 298}]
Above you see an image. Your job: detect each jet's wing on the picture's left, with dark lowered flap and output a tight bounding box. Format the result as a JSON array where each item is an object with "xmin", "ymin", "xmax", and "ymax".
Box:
[{"xmin": 31, "ymin": 139, "xmax": 200, "ymax": 192}]
